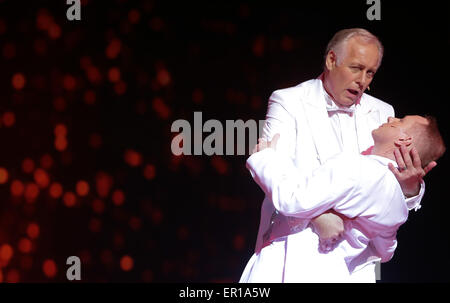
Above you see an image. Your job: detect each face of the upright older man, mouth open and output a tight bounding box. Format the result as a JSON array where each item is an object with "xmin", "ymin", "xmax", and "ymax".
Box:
[{"xmin": 326, "ymin": 37, "xmax": 379, "ymax": 107}]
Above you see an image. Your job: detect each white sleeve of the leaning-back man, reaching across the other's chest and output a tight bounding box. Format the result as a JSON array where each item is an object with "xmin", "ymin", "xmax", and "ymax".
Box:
[{"xmin": 247, "ymin": 148, "xmax": 365, "ymax": 218}]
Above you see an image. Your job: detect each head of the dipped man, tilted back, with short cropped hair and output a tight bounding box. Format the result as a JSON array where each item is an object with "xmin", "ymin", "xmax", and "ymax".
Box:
[{"xmin": 372, "ymin": 116, "xmax": 446, "ymax": 167}]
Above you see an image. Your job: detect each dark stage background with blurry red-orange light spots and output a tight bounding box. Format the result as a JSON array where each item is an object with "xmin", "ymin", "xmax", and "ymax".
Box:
[{"xmin": 0, "ymin": 0, "xmax": 450, "ymax": 282}]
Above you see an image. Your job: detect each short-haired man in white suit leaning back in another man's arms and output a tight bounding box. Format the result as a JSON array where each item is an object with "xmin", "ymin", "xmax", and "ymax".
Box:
[{"xmin": 242, "ymin": 116, "xmax": 445, "ymax": 282}]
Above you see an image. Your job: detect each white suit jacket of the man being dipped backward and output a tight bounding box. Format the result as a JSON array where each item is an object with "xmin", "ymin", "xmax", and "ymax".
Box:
[{"xmin": 244, "ymin": 148, "xmax": 408, "ymax": 282}]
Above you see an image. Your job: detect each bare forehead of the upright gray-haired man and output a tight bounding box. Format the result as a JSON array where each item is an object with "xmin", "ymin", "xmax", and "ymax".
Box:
[{"xmin": 345, "ymin": 37, "xmax": 379, "ymax": 66}]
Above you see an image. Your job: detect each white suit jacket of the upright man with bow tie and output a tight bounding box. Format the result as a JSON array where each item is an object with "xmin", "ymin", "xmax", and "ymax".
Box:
[{"xmin": 255, "ymin": 79, "xmax": 424, "ymax": 253}]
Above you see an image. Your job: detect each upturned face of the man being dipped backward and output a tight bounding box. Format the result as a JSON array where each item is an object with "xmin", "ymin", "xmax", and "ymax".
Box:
[{"xmin": 372, "ymin": 116, "xmax": 428, "ymax": 145}]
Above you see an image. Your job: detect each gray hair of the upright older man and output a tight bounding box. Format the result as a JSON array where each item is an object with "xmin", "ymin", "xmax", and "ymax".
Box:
[{"xmin": 325, "ymin": 28, "xmax": 384, "ymax": 66}]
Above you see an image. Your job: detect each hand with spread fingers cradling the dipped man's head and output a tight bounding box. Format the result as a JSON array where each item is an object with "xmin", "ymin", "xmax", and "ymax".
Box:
[{"xmin": 388, "ymin": 145, "xmax": 437, "ymax": 198}]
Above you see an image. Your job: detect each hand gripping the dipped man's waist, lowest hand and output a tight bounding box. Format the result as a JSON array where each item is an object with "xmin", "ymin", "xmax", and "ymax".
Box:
[{"xmin": 311, "ymin": 210, "xmax": 345, "ymax": 252}]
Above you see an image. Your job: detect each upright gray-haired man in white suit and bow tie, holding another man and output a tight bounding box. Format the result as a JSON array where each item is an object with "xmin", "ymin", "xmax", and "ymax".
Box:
[{"xmin": 241, "ymin": 29, "xmax": 436, "ymax": 282}]
